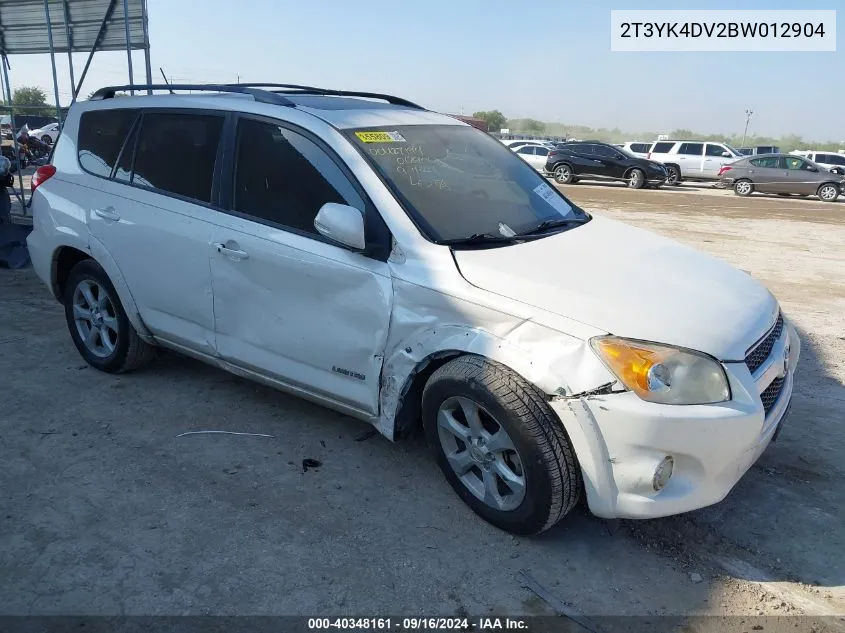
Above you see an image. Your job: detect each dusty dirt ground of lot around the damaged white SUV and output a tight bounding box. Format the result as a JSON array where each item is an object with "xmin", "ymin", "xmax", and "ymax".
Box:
[{"xmin": 0, "ymin": 180, "xmax": 845, "ymax": 630}]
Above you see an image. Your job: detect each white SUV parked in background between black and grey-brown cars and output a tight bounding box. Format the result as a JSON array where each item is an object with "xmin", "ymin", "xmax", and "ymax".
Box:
[{"xmin": 646, "ymin": 140, "xmax": 742, "ymax": 185}]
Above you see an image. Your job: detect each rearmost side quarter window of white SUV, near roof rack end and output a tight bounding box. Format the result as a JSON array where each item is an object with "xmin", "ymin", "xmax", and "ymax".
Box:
[{"xmin": 77, "ymin": 110, "xmax": 138, "ymax": 178}]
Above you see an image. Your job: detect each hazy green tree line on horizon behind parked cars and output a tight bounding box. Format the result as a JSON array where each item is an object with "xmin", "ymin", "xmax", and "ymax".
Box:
[{"xmin": 472, "ymin": 110, "xmax": 845, "ymax": 152}]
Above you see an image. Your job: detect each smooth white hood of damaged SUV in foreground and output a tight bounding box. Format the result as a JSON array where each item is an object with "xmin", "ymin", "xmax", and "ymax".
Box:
[{"xmin": 454, "ymin": 217, "xmax": 778, "ymax": 360}]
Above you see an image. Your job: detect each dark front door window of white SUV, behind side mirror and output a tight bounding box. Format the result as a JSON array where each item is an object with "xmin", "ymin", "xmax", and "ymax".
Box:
[{"xmin": 233, "ymin": 119, "xmax": 365, "ymax": 235}]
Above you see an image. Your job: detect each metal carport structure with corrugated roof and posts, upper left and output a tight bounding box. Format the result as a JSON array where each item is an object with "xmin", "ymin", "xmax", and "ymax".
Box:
[{"xmin": 0, "ymin": 0, "xmax": 152, "ymax": 216}]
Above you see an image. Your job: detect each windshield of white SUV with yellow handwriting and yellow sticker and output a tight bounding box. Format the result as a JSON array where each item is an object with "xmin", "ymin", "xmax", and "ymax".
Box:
[{"xmin": 348, "ymin": 125, "xmax": 588, "ymax": 242}]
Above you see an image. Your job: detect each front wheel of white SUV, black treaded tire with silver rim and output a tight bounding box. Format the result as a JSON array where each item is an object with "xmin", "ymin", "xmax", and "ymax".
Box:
[{"xmin": 422, "ymin": 355, "xmax": 583, "ymax": 535}]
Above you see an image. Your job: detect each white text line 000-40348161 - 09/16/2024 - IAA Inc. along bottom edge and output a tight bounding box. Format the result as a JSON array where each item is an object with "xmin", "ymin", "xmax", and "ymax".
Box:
[{"xmin": 308, "ymin": 617, "xmax": 528, "ymax": 631}]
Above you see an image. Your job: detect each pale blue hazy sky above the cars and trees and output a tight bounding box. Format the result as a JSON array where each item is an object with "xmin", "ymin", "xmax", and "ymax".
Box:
[{"xmin": 3, "ymin": 0, "xmax": 845, "ymax": 141}]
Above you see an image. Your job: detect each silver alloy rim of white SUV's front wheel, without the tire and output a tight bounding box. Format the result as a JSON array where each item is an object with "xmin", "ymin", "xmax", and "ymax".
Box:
[{"xmin": 437, "ymin": 396, "xmax": 526, "ymax": 511}]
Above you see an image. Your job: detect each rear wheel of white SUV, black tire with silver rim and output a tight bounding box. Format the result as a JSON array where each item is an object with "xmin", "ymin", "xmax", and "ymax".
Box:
[{"xmin": 64, "ymin": 259, "xmax": 156, "ymax": 374}]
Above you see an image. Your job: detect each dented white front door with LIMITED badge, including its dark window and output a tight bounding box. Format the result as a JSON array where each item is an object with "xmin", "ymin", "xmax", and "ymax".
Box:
[{"xmin": 211, "ymin": 118, "xmax": 393, "ymax": 414}]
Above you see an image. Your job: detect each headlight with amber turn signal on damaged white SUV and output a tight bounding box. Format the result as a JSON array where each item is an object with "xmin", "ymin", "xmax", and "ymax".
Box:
[{"xmin": 590, "ymin": 336, "xmax": 731, "ymax": 404}]
